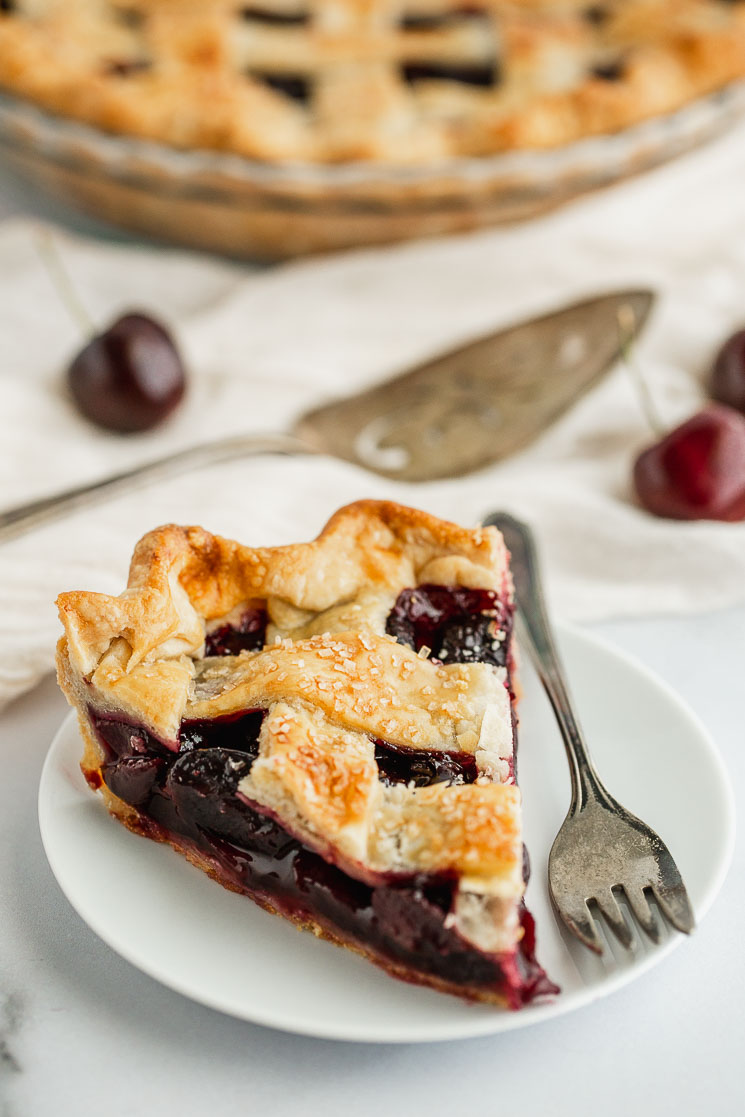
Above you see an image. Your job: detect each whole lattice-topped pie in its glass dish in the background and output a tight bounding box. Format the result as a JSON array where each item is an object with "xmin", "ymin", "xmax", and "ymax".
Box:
[{"xmin": 0, "ymin": 0, "xmax": 745, "ymax": 258}]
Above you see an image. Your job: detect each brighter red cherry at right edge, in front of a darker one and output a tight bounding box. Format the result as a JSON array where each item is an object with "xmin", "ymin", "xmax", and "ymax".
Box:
[{"xmin": 633, "ymin": 403, "xmax": 745, "ymax": 522}]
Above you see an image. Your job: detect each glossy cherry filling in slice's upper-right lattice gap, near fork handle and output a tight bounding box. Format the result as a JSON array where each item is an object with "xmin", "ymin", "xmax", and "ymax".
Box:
[{"xmin": 385, "ymin": 585, "xmax": 513, "ymax": 667}]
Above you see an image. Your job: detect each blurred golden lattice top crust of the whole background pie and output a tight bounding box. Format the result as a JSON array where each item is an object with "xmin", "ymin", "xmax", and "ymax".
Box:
[{"xmin": 0, "ymin": 0, "xmax": 745, "ymax": 163}]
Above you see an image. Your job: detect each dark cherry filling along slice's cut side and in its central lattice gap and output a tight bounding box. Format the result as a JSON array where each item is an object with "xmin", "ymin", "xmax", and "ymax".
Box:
[{"xmin": 92, "ymin": 710, "xmax": 555, "ymax": 1008}]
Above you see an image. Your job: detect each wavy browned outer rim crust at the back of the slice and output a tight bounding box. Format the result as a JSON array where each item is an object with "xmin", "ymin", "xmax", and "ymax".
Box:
[{"xmin": 57, "ymin": 500, "xmax": 509, "ymax": 675}]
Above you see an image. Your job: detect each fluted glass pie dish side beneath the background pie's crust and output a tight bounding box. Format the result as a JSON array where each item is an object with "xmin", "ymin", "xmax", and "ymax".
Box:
[{"xmin": 0, "ymin": 82, "xmax": 745, "ymax": 259}]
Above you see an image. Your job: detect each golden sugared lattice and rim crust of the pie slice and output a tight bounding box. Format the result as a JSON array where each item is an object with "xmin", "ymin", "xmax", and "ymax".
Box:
[{"xmin": 58, "ymin": 502, "xmax": 524, "ymax": 969}]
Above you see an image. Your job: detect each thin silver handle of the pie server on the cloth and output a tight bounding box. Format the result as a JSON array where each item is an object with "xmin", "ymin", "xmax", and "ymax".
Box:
[{"xmin": 0, "ymin": 435, "xmax": 317, "ymax": 543}]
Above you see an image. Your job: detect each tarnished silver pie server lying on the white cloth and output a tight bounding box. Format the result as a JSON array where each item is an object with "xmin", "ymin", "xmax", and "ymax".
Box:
[{"xmin": 0, "ymin": 290, "xmax": 655, "ymax": 542}]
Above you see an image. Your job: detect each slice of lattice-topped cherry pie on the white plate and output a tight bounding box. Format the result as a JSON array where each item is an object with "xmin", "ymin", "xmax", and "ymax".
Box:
[{"xmin": 58, "ymin": 502, "xmax": 556, "ymax": 1008}]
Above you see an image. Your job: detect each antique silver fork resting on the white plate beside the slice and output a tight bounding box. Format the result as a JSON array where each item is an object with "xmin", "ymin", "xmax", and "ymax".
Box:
[{"xmin": 485, "ymin": 513, "xmax": 695, "ymax": 954}]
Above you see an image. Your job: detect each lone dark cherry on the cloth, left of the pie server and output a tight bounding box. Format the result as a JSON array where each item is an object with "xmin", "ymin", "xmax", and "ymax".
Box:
[{"xmin": 67, "ymin": 314, "xmax": 185, "ymax": 433}]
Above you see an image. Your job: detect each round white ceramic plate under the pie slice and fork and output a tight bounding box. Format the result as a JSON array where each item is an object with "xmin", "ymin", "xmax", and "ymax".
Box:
[{"xmin": 39, "ymin": 628, "xmax": 734, "ymax": 1043}]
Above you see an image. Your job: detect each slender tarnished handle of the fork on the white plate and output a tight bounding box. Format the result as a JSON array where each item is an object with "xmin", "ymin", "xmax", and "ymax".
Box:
[{"xmin": 485, "ymin": 513, "xmax": 608, "ymax": 811}]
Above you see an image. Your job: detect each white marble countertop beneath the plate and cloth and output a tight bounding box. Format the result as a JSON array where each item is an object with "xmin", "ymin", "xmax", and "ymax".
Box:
[{"xmin": 0, "ymin": 165, "xmax": 745, "ymax": 1117}]
